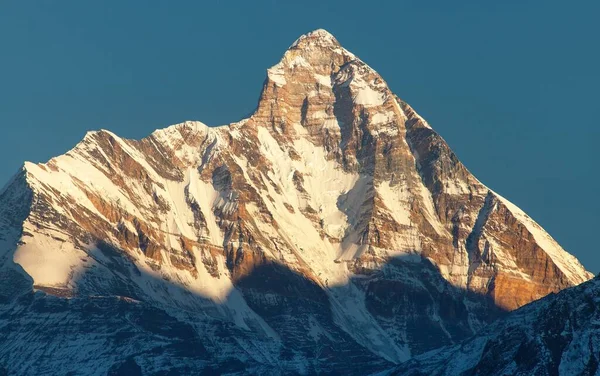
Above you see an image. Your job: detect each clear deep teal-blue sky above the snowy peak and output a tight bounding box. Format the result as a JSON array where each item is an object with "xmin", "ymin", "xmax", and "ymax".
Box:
[{"xmin": 0, "ymin": 0, "xmax": 600, "ymax": 273}]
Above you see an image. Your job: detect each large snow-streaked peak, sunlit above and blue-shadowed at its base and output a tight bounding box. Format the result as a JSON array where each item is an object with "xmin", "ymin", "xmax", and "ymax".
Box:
[{"xmin": 0, "ymin": 30, "xmax": 591, "ymax": 374}]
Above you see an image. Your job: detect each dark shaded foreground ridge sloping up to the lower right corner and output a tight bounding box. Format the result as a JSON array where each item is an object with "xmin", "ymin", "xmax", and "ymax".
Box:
[{"xmin": 384, "ymin": 277, "xmax": 600, "ymax": 376}]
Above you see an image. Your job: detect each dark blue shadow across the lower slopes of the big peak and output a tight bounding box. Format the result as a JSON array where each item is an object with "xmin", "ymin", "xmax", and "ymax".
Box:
[{"xmin": 0, "ymin": 231, "xmax": 503, "ymax": 375}]
